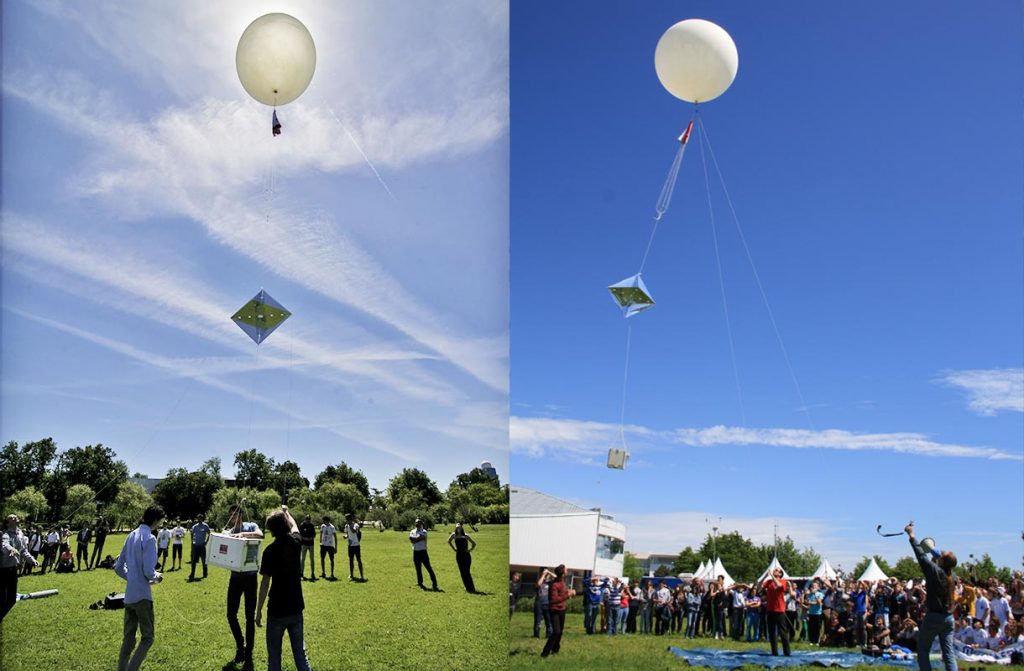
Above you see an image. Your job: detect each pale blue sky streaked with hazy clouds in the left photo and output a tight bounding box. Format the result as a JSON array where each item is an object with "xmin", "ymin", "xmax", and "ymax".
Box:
[{"xmin": 0, "ymin": 0, "xmax": 509, "ymax": 488}]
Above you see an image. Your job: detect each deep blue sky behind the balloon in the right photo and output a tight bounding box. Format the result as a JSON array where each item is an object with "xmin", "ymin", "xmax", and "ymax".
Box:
[{"xmin": 510, "ymin": 0, "xmax": 1024, "ymax": 569}]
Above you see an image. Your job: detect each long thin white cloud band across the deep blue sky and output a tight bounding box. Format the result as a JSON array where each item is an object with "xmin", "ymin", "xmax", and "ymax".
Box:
[{"xmin": 510, "ymin": 417, "xmax": 1024, "ymax": 462}]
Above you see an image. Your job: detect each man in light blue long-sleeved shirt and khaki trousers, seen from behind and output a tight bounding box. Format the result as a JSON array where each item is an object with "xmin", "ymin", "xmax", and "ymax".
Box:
[{"xmin": 114, "ymin": 505, "xmax": 164, "ymax": 671}]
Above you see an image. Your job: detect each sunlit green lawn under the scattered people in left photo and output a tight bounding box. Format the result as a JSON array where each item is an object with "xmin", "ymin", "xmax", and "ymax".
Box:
[{"xmin": 0, "ymin": 525, "xmax": 509, "ymax": 671}]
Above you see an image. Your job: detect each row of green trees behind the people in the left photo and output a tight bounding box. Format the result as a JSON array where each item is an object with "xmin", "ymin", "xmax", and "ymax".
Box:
[{"xmin": 0, "ymin": 437, "xmax": 509, "ymax": 529}]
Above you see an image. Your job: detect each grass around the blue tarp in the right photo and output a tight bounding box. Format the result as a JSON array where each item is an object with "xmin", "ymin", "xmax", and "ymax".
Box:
[{"xmin": 509, "ymin": 612, "xmax": 1005, "ymax": 671}]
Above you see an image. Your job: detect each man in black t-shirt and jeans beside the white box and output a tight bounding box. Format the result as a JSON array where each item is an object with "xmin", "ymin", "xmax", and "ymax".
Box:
[{"xmin": 256, "ymin": 506, "xmax": 311, "ymax": 671}]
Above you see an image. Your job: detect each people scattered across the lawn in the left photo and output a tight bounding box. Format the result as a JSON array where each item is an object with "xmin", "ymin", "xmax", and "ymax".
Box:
[{"xmin": 0, "ymin": 505, "xmax": 478, "ymax": 671}]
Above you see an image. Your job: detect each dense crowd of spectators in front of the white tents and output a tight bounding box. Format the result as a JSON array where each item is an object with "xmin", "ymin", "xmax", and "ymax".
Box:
[{"xmin": 520, "ymin": 559, "xmax": 1024, "ymax": 667}]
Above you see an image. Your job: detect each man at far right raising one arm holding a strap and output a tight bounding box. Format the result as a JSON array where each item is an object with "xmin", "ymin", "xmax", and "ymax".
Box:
[{"xmin": 903, "ymin": 521, "xmax": 956, "ymax": 671}]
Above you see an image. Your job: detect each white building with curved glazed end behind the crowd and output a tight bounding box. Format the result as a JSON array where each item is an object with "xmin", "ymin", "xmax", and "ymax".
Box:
[{"xmin": 509, "ymin": 485, "xmax": 626, "ymax": 577}]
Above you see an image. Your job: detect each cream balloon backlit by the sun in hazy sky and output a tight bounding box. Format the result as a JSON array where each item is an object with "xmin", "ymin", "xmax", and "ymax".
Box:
[{"xmin": 234, "ymin": 13, "xmax": 316, "ymax": 106}]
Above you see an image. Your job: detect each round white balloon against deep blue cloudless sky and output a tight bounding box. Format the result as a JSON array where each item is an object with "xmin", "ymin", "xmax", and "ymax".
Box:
[{"xmin": 654, "ymin": 18, "xmax": 739, "ymax": 102}]
